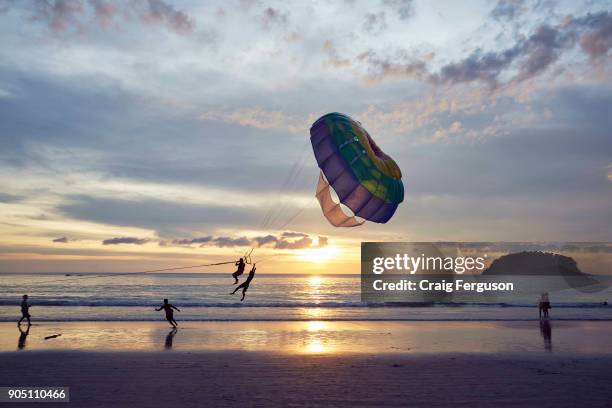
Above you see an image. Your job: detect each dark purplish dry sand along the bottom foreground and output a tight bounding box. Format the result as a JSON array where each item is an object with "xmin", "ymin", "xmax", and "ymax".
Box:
[{"xmin": 0, "ymin": 351, "xmax": 612, "ymax": 407}]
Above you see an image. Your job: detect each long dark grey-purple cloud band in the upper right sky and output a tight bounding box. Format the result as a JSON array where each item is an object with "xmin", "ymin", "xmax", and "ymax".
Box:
[{"xmin": 357, "ymin": 11, "xmax": 612, "ymax": 88}]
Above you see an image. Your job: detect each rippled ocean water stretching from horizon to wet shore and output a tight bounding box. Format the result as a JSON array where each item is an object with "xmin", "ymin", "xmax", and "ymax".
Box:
[{"xmin": 0, "ymin": 273, "xmax": 612, "ymax": 322}]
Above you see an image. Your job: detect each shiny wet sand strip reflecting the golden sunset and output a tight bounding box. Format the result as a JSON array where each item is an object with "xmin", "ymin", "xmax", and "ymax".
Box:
[{"xmin": 0, "ymin": 321, "xmax": 612, "ymax": 354}]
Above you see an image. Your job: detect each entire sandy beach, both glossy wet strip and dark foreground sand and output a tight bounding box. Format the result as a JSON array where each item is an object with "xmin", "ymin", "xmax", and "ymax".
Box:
[{"xmin": 0, "ymin": 321, "xmax": 612, "ymax": 407}]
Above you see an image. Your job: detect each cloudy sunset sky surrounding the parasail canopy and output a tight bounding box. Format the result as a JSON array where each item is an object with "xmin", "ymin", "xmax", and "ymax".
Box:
[{"xmin": 0, "ymin": 0, "xmax": 612, "ymax": 273}]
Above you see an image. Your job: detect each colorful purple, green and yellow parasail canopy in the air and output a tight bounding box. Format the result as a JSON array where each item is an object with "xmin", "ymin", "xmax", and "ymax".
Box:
[{"xmin": 310, "ymin": 113, "xmax": 404, "ymax": 227}]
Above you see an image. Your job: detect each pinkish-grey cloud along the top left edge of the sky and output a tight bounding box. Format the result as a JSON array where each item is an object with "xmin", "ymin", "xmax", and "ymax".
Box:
[{"xmin": 5, "ymin": 0, "xmax": 195, "ymax": 34}]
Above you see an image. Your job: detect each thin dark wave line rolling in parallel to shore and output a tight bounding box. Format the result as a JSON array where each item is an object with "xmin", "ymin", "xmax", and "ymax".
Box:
[{"xmin": 0, "ymin": 299, "xmax": 612, "ymax": 309}]
